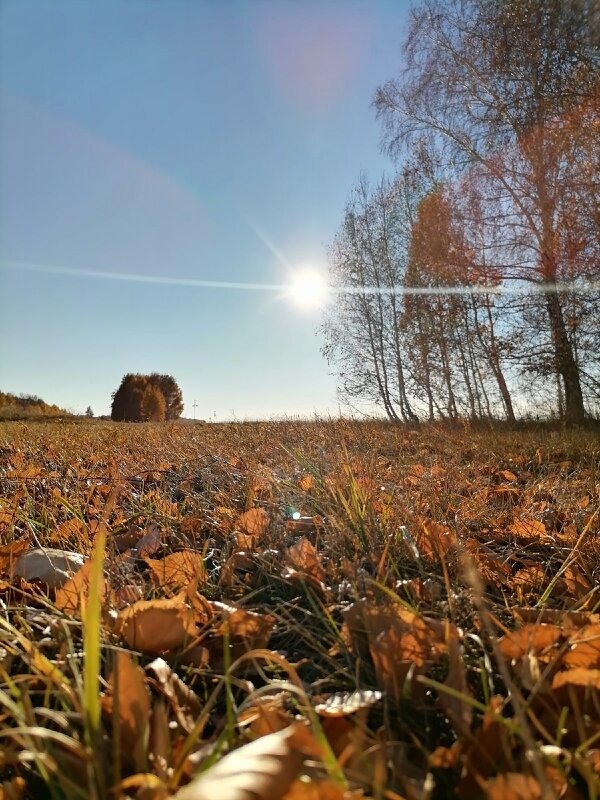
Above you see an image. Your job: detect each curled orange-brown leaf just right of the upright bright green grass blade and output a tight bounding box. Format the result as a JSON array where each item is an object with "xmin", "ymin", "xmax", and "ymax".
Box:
[{"xmin": 115, "ymin": 594, "xmax": 196, "ymax": 654}]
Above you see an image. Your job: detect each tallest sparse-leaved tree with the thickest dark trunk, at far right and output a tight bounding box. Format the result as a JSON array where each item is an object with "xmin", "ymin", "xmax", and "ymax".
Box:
[{"xmin": 375, "ymin": 0, "xmax": 600, "ymax": 422}]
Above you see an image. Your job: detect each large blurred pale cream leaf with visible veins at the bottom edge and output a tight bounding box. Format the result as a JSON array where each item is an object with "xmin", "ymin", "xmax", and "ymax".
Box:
[{"xmin": 174, "ymin": 725, "xmax": 304, "ymax": 800}]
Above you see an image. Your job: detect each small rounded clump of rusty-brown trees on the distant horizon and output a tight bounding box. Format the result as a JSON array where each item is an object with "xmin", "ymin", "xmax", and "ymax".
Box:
[{"xmin": 111, "ymin": 372, "xmax": 183, "ymax": 422}]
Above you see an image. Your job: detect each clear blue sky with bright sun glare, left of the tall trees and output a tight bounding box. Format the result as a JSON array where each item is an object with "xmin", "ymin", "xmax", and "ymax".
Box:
[{"xmin": 0, "ymin": 0, "xmax": 409, "ymax": 420}]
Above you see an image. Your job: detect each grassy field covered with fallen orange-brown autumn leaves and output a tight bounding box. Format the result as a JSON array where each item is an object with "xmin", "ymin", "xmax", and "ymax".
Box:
[{"xmin": 0, "ymin": 421, "xmax": 600, "ymax": 800}]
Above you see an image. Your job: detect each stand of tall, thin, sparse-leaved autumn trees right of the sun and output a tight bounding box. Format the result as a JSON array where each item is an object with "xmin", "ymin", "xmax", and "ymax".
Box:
[{"xmin": 323, "ymin": 0, "xmax": 600, "ymax": 423}]
